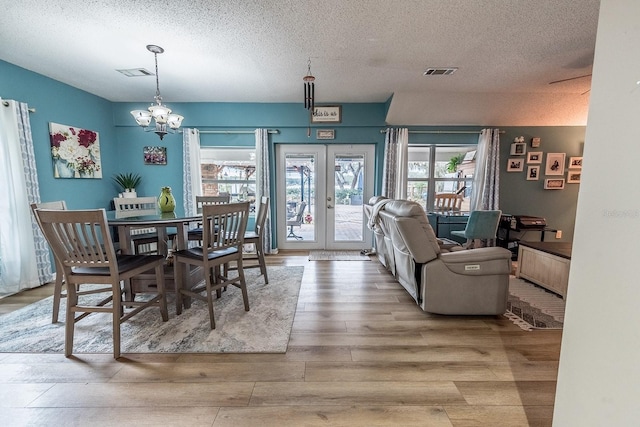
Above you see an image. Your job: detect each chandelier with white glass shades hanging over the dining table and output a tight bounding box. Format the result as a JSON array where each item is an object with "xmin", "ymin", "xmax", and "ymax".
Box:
[{"xmin": 131, "ymin": 44, "xmax": 184, "ymax": 140}]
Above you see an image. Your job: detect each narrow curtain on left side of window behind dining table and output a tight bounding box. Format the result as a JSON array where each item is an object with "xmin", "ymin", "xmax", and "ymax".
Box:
[{"xmin": 182, "ymin": 128, "xmax": 202, "ymax": 216}]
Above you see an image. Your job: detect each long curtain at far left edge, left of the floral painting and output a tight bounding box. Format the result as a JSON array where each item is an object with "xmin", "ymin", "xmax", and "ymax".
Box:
[{"xmin": 0, "ymin": 99, "xmax": 53, "ymax": 297}]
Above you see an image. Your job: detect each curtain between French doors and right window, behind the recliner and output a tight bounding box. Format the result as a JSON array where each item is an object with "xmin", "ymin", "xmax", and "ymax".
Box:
[{"xmin": 382, "ymin": 128, "xmax": 409, "ymax": 199}]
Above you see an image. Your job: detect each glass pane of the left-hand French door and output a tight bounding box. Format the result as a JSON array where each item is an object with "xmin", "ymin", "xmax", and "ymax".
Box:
[{"xmin": 282, "ymin": 153, "xmax": 317, "ymax": 241}]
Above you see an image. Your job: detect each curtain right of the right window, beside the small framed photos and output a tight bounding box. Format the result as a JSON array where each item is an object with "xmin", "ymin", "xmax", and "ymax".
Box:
[{"xmin": 470, "ymin": 129, "xmax": 500, "ymax": 211}]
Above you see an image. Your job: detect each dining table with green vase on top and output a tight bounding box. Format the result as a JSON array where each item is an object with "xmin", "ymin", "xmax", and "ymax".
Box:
[{"xmin": 106, "ymin": 207, "xmax": 204, "ymax": 293}]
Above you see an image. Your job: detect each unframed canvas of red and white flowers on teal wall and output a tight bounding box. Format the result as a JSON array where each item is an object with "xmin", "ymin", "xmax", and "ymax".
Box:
[{"xmin": 49, "ymin": 122, "xmax": 102, "ymax": 179}]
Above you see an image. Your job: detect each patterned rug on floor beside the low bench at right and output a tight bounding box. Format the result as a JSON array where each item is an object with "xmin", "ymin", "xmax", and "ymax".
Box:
[{"xmin": 505, "ymin": 276, "xmax": 565, "ymax": 331}]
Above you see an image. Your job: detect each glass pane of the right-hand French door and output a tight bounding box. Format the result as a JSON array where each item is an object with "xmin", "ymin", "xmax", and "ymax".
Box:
[{"xmin": 327, "ymin": 155, "xmax": 365, "ymax": 242}]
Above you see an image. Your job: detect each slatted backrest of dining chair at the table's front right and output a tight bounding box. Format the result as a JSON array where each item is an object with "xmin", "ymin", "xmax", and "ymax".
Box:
[{"xmin": 202, "ymin": 202, "xmax": 249, "ymax": 252}]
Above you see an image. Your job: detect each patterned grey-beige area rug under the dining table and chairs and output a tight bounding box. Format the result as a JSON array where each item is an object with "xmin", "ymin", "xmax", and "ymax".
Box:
[{"xmin": 0, "ymin": 267, "xmax": 304, "ymax": 354}]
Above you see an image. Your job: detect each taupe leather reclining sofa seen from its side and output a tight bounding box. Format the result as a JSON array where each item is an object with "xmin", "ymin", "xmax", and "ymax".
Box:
[{"xmin": 377, "ymin": 200, "xmax": 511, "ymax": 315}]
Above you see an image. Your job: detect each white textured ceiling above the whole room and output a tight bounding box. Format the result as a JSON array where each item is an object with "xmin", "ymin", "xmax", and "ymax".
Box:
[{"xmin": 0, "ymin": 0, "xmax": 600, "ymax": 126}]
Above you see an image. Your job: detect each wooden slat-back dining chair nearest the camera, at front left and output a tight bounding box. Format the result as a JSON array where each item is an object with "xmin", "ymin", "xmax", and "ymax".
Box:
[{"xmin": 34, "ymin": 209, "xmax": 169, "ymax": 359}]
